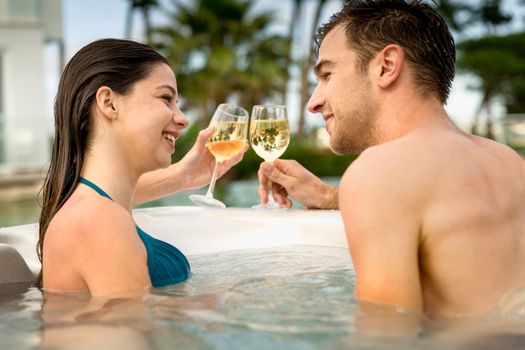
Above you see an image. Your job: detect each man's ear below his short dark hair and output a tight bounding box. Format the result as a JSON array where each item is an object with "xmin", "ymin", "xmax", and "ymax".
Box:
[{"xmin": 375, "ymin": 44, "xmax": 405, "ymax": 88}]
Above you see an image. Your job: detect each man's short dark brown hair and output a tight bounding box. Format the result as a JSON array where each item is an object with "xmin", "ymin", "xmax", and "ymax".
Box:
[{"xmin": 316, "ymin": 0, "xmax": 456, "ymax": 104}]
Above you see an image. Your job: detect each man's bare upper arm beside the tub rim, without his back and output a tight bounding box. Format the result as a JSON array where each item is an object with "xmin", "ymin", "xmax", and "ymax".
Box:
[{"xmin": 339, "ymin": 150, "xmax": 423, "ymax": 312}]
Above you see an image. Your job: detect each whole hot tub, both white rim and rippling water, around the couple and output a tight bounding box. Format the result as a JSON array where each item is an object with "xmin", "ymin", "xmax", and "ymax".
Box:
[{"xmin": 0, "ymin": 207, "xmax": 525, "ymax": 350}]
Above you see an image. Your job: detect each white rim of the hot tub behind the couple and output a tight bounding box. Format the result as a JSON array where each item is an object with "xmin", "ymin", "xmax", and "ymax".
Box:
[{"xmin": 0, "ymin": 206, "xmax": 347, "ymax": 274}]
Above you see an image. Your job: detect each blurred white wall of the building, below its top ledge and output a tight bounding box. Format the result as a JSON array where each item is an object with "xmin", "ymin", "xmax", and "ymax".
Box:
[{"xmin": 0, "ymin": 26, "xmax": 51, "ymax": 168}]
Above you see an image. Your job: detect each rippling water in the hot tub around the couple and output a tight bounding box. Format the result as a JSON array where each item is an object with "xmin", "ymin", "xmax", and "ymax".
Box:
[{"xmin": 0, "ymin": 245, "xmax": 525, "ymax": 350}]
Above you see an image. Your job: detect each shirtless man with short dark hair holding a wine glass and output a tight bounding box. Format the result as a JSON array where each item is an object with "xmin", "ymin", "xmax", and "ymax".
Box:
[{"xmin": 259, "ymin": 0, "xmax": 525, "ymax": 316}]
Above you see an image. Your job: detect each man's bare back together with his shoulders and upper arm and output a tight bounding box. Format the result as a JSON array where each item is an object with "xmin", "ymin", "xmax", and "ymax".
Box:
[{"xmin": 340, "ymin": 128, "xmax": 525, "ymax": 316}]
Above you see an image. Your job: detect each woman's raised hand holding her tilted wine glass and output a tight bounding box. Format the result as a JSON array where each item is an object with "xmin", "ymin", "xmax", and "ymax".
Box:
[{"xmin": 176, "ymin": 126, "xmax": 249, "ymax": 191}]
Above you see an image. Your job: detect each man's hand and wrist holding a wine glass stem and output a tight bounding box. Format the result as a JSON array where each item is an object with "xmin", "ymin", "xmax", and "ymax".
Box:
[{"xmin": 257, "ymin": 159, "xmax": 338, "ymax": 209}]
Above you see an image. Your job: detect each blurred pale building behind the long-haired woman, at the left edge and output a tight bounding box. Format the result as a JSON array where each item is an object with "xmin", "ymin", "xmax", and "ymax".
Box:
[{"xmin": 0, "ymin": 0, "xmax": 63, "ymax": 173}]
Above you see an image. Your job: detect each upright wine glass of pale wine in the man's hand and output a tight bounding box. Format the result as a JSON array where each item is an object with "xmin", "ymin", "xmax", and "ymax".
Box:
[{"xmin": 250, "ymin": 105, "xmax": 290, "ymax": 209}]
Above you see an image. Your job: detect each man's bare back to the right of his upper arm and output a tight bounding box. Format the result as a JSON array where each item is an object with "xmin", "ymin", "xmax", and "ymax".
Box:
[{"xmin": 416, "ymin": 133, "xmax": 525, "ymax": 314}]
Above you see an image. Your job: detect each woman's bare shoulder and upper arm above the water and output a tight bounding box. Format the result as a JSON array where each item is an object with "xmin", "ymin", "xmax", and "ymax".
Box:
[{"xmin": 44, "ymin": 196, "xmax": 149, "ymax": 295}]
